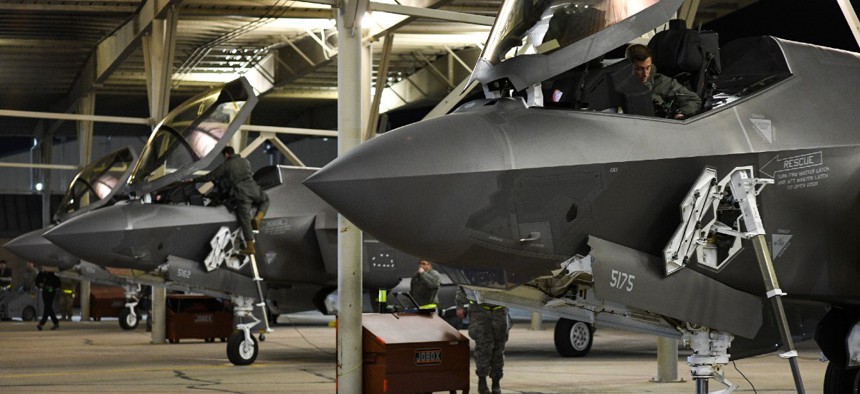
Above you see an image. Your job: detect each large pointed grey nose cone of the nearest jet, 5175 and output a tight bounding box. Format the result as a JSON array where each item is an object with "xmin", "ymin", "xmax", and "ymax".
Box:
[{"xmin": 304, "ymin": 114, "xmax": 509, "ymax": 261}]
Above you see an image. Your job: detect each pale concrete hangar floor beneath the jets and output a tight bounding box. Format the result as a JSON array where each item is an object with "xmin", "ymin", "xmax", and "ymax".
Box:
[{"xmin": 0, "ymin": 316, "xmax": 826, "ymax": 393}]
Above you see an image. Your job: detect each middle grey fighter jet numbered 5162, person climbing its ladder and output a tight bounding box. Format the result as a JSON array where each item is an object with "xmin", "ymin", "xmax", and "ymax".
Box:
[{"xmin": 45, "ymin": 78, "xmax": 430, "ymax": 365}]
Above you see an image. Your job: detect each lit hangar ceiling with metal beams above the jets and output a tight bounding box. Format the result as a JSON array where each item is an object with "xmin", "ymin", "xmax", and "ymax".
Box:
[{"xmin": 0, "ymin": 0, "xmax": 755, "ymax": 142}]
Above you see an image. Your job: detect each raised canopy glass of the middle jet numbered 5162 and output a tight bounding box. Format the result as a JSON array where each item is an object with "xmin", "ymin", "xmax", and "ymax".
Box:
[{"xmin": 129, "ymin": 79, "xmax": 256, "ymax": 192}]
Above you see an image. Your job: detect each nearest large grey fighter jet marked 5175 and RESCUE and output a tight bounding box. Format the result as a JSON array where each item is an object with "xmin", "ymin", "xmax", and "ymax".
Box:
[{"xmin": 305, "ymin": 0, "xmax": 860, "ymax": 392}]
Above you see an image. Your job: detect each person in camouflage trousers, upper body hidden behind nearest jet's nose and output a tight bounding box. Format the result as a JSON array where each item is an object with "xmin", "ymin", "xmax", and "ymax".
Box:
[{"xmin": 456, "ymin": 287, "xmax": 508, "ymax": 394}]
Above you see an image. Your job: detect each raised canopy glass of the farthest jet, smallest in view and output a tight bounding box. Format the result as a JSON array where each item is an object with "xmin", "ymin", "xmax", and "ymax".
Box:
[{"xmin": 54, "ymin": 148, "xmax": 136, "ymax": 221}]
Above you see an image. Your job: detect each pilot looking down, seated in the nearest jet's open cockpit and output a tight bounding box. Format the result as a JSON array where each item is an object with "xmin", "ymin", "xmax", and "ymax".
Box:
[{"xmin": 625, "ymin": 44, "xmax": 702, "ymax": 119}]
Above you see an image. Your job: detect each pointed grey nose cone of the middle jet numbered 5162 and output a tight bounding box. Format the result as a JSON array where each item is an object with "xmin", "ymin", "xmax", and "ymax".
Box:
[{"xmin": 44, "ymin": 205, "xmax": 130, "ymax": 267}]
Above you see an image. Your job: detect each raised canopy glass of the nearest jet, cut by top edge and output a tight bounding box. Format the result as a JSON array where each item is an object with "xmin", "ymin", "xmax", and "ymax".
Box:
[{"xmin": 473, "ymin": 0, "xmax": 682, "ymax": 90}]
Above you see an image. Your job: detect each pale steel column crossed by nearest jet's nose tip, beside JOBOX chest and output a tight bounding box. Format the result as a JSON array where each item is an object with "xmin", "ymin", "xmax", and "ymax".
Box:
[{"xmin": 337, "ymin": 0, "xmax": 367, "ymax": 393}]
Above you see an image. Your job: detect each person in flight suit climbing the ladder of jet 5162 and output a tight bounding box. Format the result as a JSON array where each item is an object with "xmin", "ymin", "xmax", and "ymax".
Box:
[{"xmin": 193, "ymin": 146, "xmax": 269, "ymax": 255}]
